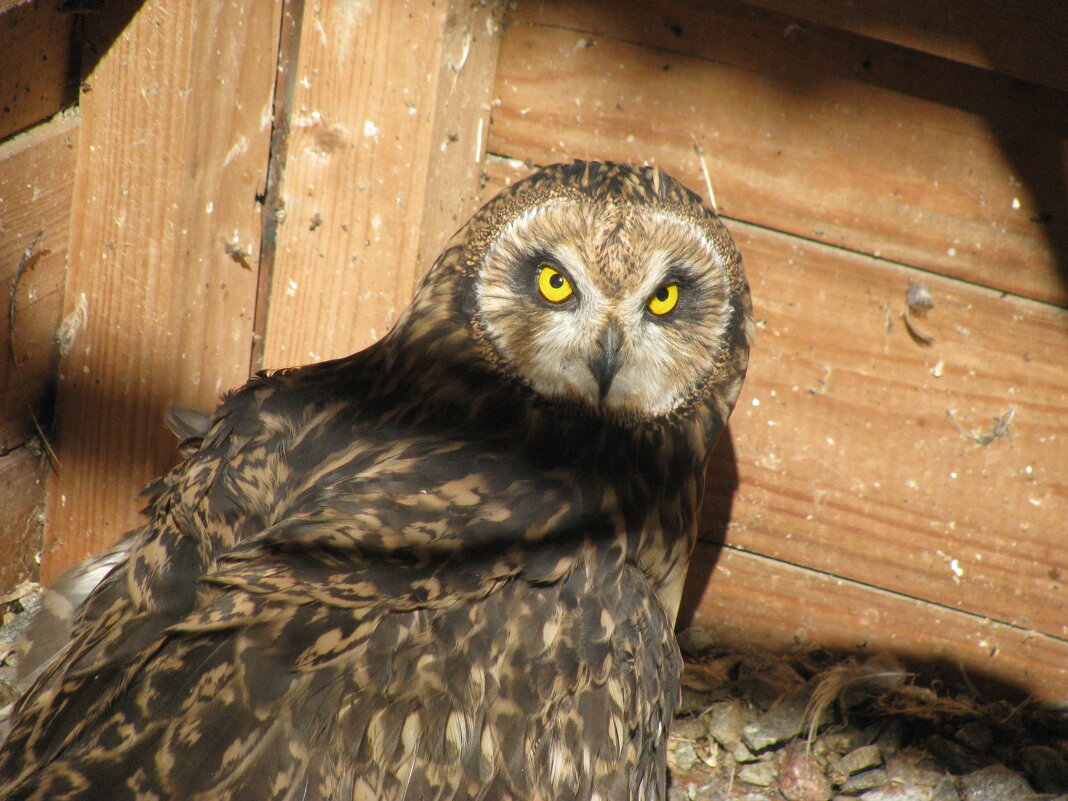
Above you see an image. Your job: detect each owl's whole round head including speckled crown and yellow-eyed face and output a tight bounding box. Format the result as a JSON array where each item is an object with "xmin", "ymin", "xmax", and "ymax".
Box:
[{"xmin": 401, "ymin": 161, "xmax": 752, "ymax": 429}]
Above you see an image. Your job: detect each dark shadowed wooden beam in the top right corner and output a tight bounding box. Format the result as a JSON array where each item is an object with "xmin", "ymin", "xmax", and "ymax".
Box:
[{"xmin": 747, "ymin": 0, "xmax": 1068, "ymax": 91}]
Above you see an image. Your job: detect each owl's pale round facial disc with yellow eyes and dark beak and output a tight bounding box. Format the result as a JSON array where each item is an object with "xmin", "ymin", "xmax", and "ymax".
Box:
[{"xmin": 476, "ymin": 200, "xmax": 731, "ymax": 418}]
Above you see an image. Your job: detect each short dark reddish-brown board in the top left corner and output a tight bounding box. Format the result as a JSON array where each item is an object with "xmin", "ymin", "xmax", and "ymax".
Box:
[{"xmin": 0, "ymin": 0, "xmax": 74, "ymax": 139}]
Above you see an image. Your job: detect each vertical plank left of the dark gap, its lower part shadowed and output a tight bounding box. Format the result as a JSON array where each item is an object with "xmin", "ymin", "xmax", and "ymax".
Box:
[{"xmin": 42, "ymin": 0, "xmax": 280, "ymax": 581}]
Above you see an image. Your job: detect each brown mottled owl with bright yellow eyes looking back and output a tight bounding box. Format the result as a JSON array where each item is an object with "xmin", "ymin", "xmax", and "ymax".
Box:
[{"xmin": 0, "ymin": 162, "xmax": 753, "ymax": 801}]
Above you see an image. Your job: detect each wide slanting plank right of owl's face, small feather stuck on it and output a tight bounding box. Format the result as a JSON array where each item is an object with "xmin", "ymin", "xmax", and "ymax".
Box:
[{"xmin": 487, "ymin": 153, "xmax": 1068, "ymax": 638}]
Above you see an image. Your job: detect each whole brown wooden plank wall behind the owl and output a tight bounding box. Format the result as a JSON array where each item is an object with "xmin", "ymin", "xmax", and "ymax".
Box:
[{"xmin": 0, "ymin": 0, "xmax": 1068, "ymax": 698}]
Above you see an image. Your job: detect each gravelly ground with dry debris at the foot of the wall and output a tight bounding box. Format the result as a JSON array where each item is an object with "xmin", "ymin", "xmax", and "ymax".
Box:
[{"xmin": 0, "ymin": 584, "xmax": 1068, "ymax": 801}]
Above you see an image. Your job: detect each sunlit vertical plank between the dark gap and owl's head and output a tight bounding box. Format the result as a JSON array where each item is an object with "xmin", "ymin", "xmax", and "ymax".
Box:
[{"xmin": 264, "ymin": 0, "xmax": 501, "ymax": 367}]
